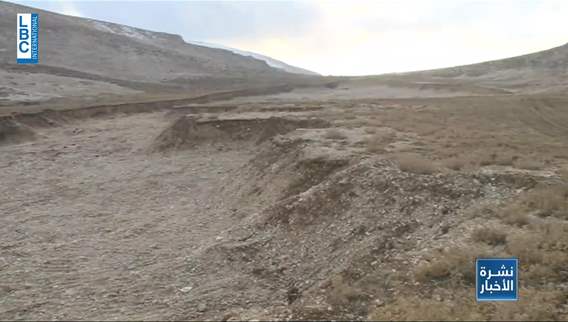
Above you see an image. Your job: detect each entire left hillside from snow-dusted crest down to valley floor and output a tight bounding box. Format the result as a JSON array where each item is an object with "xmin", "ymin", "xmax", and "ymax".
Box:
[{"xmin": 0, "ymin": 2, "xmax": 326, "ymax": 105}]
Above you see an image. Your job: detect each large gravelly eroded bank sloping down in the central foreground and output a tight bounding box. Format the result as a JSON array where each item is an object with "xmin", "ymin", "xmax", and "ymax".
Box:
[{"xmin": 185, "ymin": 145, "xmax": 536, "ymax": 319}]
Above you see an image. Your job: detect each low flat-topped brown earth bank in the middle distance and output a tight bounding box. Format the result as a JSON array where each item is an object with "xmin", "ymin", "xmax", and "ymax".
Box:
[{"xmin": 150, "ymin": 116, "xmax": 329, "ymax": 152}]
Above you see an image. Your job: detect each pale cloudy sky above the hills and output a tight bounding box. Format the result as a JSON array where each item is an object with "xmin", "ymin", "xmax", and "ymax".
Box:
[{"xmin": 10, "ymin": 0, "xmax": 568, "ymax": 75}]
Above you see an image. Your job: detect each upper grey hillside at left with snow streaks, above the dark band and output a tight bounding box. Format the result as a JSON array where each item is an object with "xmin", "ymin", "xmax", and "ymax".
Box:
[{"xmin": 0, "ymin": 2, "xmax": 292, "ymax": 82}]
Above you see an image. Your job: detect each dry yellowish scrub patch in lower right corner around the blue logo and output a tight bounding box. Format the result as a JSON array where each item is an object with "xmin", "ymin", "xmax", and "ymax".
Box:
[{"xmin": 402, "ymin": 185, "xmax": 568, "ymax": 321}]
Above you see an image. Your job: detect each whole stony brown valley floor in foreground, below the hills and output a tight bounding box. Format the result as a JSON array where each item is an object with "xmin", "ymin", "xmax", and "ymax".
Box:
[{"xmin": 0, "ymin": 83, "xmax": 568, "ymax": 320}]
